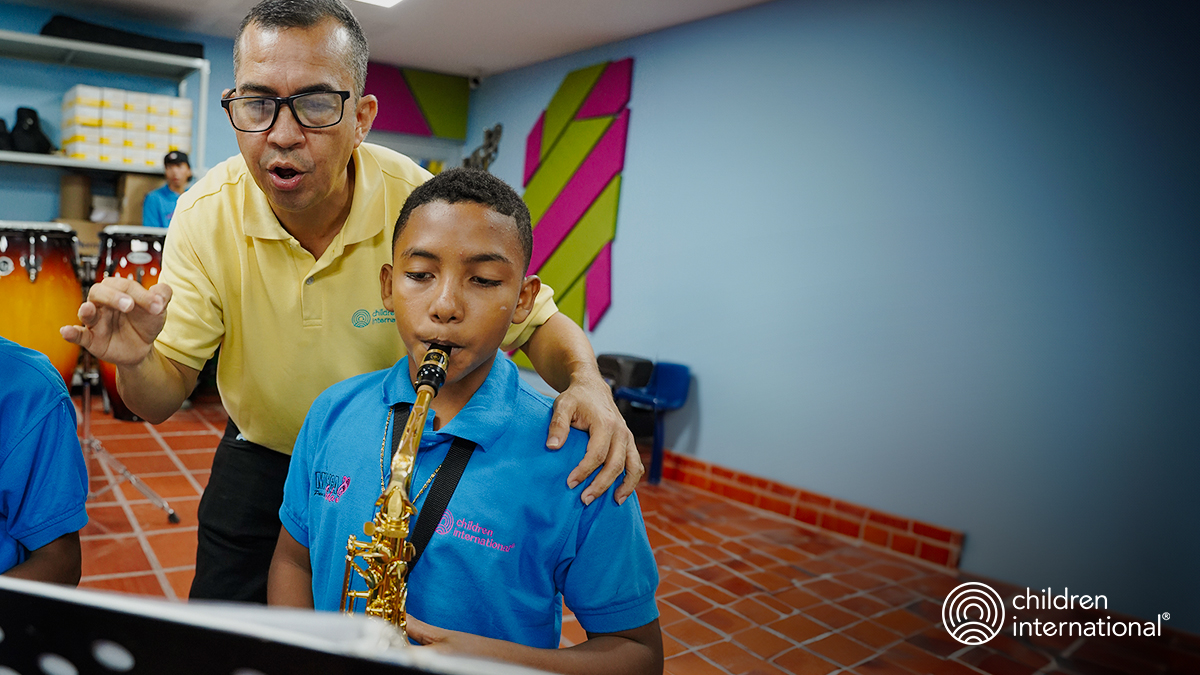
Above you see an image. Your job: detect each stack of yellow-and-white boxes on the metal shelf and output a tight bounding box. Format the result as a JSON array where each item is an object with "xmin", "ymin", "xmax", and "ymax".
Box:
[{"xmin": 62, "ymin": 84, "xmax": 192, "ymax": 168}]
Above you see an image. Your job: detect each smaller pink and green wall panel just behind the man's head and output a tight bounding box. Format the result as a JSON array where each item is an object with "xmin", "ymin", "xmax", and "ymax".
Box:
[{"xmin": 365, "ymin": 62, "xmax": 470, "ymax": 141}]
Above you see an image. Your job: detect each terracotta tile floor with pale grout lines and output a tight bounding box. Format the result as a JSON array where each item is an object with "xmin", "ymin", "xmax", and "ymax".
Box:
[{"xmin": 79, "ymin": 396, "xmax": 1200, "ymax": 675}]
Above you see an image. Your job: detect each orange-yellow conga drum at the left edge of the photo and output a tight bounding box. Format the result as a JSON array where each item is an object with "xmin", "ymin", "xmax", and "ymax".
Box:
[{"xmin": 0, "ymin": 221, "xmax": 83, "ymax": 388}]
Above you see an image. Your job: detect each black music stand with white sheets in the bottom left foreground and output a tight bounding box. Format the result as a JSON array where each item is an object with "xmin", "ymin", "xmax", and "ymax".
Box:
[{"xmin": 0, "ymin": 577, "xmax": 549, "ymax": 675}]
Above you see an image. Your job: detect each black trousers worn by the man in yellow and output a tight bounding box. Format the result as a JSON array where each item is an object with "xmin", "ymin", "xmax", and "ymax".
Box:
[{"xmin": 190, "ymin": 420, "xmax": 290, "ymax": 604}]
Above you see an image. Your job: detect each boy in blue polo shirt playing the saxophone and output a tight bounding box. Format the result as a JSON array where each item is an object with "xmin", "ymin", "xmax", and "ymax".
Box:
[{"xmin": 268, "ymin": 169, "xmax": 662, "ymax": 673}]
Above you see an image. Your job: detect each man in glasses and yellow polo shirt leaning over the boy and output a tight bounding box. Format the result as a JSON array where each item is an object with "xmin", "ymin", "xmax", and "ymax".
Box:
[{"xmin": 62, "ymin": 0, "xmax": 642, "ymax": 602}]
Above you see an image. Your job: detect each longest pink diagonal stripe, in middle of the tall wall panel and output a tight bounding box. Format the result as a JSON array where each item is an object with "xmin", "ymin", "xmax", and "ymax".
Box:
[{"xmin": 529, "ymin": 108, "xmax": 629, "ymax": 274}]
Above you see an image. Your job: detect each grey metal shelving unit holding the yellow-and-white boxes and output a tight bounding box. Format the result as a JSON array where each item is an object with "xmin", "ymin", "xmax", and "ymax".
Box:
[{"xmin": 0, "ymin": 30, "xmax": 211, "ymax": 170}]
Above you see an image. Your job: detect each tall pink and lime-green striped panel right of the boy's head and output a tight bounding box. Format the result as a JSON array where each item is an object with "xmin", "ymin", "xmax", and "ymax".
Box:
[{"xmin": 523, "ymin": 59, "xmax": 634, "ymax": 330}]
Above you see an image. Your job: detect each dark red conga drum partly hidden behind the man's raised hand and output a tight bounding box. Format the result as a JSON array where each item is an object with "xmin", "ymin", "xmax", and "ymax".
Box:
[{"xmin": 96, "ymin": 225, "xmax": 167, "ymax": 420}]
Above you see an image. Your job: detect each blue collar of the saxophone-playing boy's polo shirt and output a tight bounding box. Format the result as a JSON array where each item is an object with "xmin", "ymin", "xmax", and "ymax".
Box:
[{"xmin": 383, "ymin": 353, "xmax": 520, "ymax": 450}]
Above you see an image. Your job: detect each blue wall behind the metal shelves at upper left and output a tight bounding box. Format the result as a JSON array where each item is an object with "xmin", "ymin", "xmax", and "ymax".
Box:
[{"xmin": 0, "ymin": 4, "xmax": 238, "ymax": 221}]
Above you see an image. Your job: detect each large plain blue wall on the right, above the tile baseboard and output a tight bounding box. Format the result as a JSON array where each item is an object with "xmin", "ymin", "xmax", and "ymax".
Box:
[{"xmin": 466, "ymin": 0, "xmax": 1200, "ymax": 631}]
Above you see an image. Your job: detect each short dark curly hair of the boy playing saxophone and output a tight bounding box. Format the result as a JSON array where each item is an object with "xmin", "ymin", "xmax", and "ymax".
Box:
[{"xmin": 391, "ymin": 168, "xmax": 533, "ymax": 270}]
